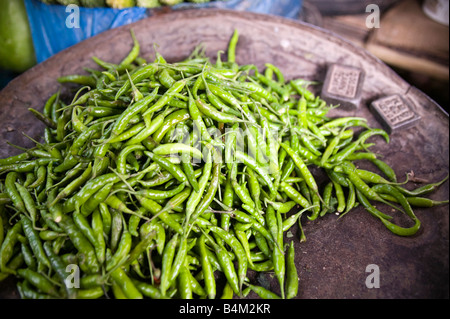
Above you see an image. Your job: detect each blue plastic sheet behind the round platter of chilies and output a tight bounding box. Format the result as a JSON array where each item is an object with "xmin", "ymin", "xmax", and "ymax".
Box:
[{"xmin": 25, "ymin": 0, "xmax": 302, "ymax": 63}]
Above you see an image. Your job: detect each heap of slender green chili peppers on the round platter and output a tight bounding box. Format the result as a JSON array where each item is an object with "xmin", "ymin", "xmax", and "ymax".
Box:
[{"xmin": 0, "ymin": 31, "xmax": 448, "ymax": 299}]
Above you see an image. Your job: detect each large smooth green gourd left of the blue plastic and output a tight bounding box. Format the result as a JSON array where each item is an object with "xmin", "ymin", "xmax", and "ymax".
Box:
[{"xmin": 0, "ymin": 0, "xmax": 36, "ymax": 72}]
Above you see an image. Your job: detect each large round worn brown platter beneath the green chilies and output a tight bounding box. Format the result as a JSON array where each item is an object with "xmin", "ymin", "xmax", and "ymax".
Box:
[{"xmin": 0, "ymin": 10, "xmax": 449, "ymax": 299}]
